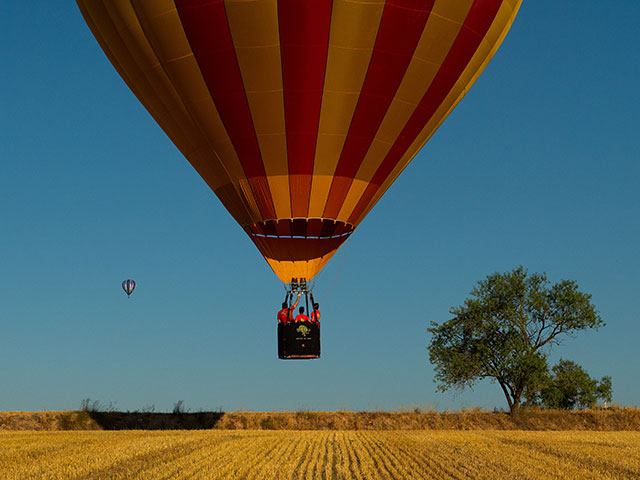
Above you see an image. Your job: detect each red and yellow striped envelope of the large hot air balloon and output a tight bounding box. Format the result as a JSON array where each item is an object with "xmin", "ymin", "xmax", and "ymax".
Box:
[{"xmin": 78, "ymin": 0, "xmax": 521, "ymax": 282}]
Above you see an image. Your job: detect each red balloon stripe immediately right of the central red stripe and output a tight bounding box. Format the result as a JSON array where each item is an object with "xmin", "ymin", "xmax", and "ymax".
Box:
[{"xmin": 324, "ymin": 0, "xmax": 435, "ymax": 218}]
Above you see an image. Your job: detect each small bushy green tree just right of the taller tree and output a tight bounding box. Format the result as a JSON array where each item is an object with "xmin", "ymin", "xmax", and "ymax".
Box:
[{"xmin": 534, "ymin": 359, "xmax": 612, "ymax": 410}]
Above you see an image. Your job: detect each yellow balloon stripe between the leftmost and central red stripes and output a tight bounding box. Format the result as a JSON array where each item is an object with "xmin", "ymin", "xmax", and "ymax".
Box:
[{"xmin": 225, "ymin": 0, "xmax": 291, "ymax": 218}]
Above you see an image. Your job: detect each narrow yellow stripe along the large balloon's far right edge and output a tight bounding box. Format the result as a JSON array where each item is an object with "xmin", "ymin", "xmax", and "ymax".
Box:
[{"xmin": 355, "ymin": 0, "xmax": 522, "ymax": 225}]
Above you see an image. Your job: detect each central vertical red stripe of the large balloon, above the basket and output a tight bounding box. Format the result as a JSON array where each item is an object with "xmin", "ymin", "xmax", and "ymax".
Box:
[{"xmin": 278, "ymin": 0, "xmax": 333, "ymax": 217}]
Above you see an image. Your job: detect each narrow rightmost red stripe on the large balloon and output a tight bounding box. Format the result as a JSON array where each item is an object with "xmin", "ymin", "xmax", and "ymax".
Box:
[{"xmin": 349, "ymin": 0, "xmax": 503, "ymax": 223}]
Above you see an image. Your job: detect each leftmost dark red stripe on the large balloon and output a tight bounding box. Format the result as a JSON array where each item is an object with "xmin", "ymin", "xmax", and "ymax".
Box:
[{"xmin": 176, "ymin": 0, "xmax": 276, "ymax": 219}]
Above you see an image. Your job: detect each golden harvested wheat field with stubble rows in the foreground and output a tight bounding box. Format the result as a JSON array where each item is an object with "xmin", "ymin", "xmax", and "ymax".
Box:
[{"xmin": 0, "ymin": 430, "xmax": 640, "ymax": 480}]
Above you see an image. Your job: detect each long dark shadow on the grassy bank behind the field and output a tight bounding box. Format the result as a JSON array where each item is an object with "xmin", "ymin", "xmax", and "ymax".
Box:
[{"xmin": 87, "ymin": 411, "xmax": 224, "ymax": 430}]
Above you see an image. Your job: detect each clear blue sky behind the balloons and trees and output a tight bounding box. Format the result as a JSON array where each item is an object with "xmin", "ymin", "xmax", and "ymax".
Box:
[{"xmin": 0, "ymin": 0, "xmax": 640, "ymax": 410}]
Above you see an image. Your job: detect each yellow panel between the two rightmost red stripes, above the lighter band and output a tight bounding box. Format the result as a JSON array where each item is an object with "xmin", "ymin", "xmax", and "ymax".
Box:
[{"xmin": 356, "ymin": 5, "xmax": 472, "ymax": 182}]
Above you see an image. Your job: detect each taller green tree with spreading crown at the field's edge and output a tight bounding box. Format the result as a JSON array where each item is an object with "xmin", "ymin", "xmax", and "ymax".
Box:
[{"xmin": 428, "ymin": 266, "xmax": 603, "ymax": 413}]
